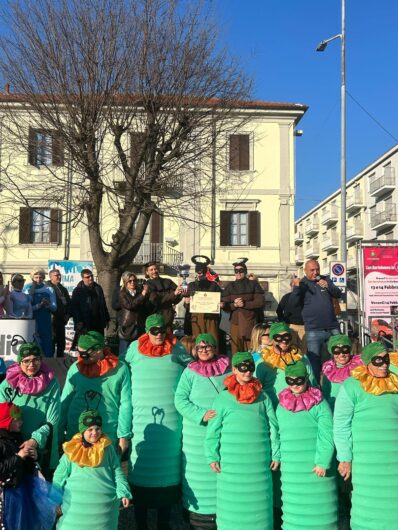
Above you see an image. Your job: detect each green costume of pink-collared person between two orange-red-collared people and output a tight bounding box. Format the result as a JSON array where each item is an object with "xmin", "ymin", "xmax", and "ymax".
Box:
[{"xmin": 175, "ymin": 356, "xmax": 228, "ymax": 514}]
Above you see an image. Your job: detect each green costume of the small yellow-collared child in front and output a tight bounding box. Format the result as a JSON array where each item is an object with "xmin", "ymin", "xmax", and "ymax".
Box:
[{"xmin": 53, "ymin": 445, "xmax": 131, "ymax": 530}]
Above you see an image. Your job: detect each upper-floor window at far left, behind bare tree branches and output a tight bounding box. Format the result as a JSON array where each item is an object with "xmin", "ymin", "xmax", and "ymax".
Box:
[{"xmin": 29, "ymin": 128, "xmax": 64, "ymax": 167}]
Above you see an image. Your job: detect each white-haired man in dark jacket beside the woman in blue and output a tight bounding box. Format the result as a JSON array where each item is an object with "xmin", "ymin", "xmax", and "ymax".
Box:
[{"xmin": 46, "ymin": 269, "xmax": 70, "ymax": 357}]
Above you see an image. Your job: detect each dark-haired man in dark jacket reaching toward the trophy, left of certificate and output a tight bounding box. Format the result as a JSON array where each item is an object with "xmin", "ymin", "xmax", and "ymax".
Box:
[{"xmin": 144, "ymin": 261, "xmax": 183, "ymax": 328}]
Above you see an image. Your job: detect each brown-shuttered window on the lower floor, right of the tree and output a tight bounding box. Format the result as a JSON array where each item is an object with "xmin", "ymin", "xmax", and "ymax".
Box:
[{"xmin": 220, "ymin": 210, "xmax": 261, "ymax": 247}]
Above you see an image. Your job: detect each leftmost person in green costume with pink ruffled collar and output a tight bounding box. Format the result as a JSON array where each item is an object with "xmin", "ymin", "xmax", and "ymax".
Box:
[{"xmin": 0, "ymin": 342, "xmax": 61, "ymax": 478}]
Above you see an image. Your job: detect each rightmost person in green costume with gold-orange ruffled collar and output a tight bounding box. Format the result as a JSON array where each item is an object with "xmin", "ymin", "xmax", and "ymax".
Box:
[{"xmin": 334, "ymin": 342, "xmax": 398, "ymax": 530}]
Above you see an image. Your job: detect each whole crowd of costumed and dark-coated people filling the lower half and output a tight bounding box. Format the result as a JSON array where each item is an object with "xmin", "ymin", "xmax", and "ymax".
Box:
[{"xmin": 0, "ymin": 260, "xmax": 398, "ymax": 530}]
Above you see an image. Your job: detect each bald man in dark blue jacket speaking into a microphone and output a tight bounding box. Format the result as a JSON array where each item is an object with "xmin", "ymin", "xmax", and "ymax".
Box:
[{"xmin": 291, "ymin": 259, "xmax": 342, "ymax": 381}]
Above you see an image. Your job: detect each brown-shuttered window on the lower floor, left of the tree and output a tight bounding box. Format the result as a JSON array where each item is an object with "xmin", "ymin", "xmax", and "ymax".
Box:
[{"xmin": 19, "ymin": 208, "xmax": 61, "ymax": 244}]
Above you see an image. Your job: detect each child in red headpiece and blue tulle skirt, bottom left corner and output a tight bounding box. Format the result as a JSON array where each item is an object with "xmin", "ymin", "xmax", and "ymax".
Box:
[{"xmin": 0, "ymin": 402, "xmax": 61, "ymax": 530}]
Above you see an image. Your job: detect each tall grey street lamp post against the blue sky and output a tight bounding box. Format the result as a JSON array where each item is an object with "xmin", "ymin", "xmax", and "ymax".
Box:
[{"xmin": 316, "ymin": 0, "xmax": 347, "ymax": 328}]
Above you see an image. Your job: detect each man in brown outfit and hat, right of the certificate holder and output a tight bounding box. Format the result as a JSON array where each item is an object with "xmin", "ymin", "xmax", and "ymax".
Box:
[{"xmin": 222, "ymin": 258, "xmax": 265, "ymax": 355}]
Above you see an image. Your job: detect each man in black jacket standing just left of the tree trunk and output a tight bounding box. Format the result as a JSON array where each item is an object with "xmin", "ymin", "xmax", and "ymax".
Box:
[{"xmin": 71, "ymin": 269, "xmax": 110, "ymax": 339}]
